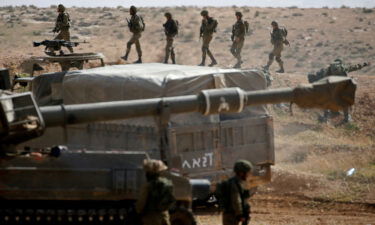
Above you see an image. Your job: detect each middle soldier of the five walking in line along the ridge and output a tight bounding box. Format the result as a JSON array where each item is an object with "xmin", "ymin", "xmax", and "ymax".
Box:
[{"xmin": 199, "ymin": 10, "xmax": 217, "ymax": 66}]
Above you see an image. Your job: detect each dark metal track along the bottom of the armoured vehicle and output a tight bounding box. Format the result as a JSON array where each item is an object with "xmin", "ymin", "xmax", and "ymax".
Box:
[{"xmin": 0, "ymin": 201, "xmax": 136, "ymax": 225}]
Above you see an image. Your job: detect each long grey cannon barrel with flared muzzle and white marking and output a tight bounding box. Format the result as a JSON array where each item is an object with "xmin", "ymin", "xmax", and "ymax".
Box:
[{"xmin": 40, "ymin": 76, "xmax": 356, "ymax": 126}]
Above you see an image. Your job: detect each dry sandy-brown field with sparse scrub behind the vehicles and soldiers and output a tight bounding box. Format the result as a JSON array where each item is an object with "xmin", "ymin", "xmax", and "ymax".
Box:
[{"xmin": 0, "ymin": 6, "xmax": 375, "ymax": 225}]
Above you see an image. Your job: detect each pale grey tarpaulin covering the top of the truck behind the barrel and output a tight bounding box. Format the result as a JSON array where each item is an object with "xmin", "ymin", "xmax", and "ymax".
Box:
[{"xmin": 34, "ymin": 63, "xmax": 267, "ymax": 125}]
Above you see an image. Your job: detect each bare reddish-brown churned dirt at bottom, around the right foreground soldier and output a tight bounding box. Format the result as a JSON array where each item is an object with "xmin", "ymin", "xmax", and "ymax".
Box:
[{"xmin": 197, "ymin": 193, "xmax": 375, "ymax": 225}]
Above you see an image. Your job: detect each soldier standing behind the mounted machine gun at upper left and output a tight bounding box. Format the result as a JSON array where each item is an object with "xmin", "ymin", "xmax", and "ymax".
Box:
[{"xmin": 52, "ymin": 4, "xmax": 73, "ymax": 53}]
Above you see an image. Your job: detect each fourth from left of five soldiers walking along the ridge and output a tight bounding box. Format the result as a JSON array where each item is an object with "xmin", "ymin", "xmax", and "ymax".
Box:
[{"xmin": 230, "ymin": 12, "xmax": 246, "ymax": 68}]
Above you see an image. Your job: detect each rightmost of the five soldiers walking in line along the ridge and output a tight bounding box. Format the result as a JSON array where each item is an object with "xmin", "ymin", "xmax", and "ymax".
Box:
[{"xmin": 264, "ymin": 21, "xmax": 289, "ymax": 73}]
